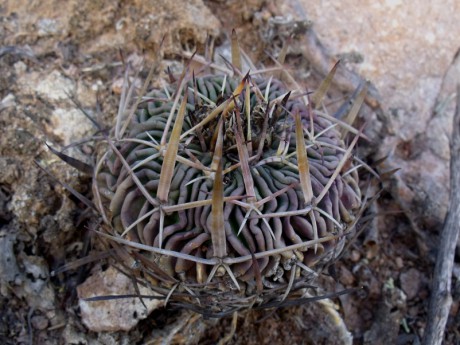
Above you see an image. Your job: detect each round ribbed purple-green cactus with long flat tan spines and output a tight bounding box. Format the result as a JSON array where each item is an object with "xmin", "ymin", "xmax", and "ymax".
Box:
[{"xmin": 93, "ymin": 33, "xmax": 370, "ymax": 315}]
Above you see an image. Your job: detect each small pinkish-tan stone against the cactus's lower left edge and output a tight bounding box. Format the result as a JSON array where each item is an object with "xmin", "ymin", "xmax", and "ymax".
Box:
[{"xmin": 77, "ymin": 266, "xmax": 163, "ymax": 332}]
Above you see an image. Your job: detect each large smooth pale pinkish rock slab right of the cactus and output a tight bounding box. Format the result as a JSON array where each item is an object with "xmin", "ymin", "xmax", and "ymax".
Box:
[{"xmin": 293, "ymin": 0, "xmax": 460, "ymax": 229}]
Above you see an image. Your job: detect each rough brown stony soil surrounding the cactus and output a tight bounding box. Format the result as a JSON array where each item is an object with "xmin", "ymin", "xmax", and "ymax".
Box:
[{"xmin": 0, "ymin": 0, "xmax": 460, "ymax": 344}]
